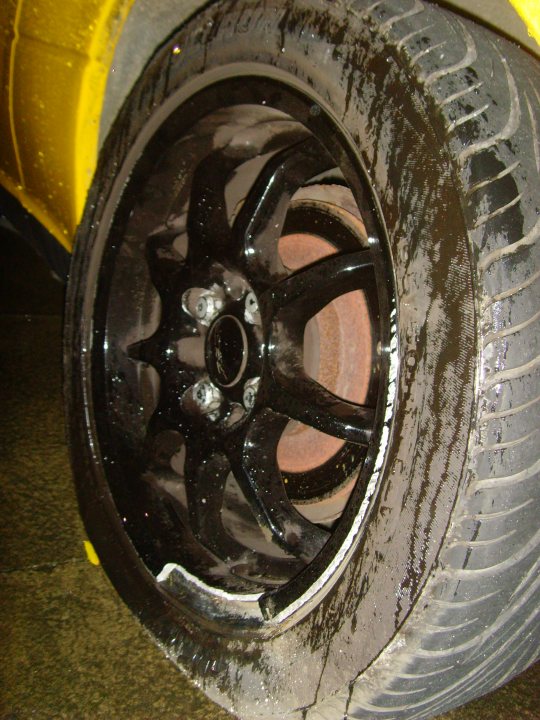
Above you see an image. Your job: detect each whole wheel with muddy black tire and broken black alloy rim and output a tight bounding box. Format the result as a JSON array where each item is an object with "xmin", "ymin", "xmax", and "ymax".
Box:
[{"xmin": 65, "ymin": 0, "xmax": 540, "ymax": 720}]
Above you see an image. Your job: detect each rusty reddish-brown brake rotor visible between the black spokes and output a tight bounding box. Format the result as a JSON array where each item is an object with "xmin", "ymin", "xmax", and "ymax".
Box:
[{"xmin": 277, "ymin": 185, "xmax": 373, "ymax": 522}]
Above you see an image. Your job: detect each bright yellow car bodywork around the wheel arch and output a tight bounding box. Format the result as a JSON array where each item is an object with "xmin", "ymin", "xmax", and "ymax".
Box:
[{"xmin": 0, "ymin": 0, "xmax": 540, "ymax": 250}]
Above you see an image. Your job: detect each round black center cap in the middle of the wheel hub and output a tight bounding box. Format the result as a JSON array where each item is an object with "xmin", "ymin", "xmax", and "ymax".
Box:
[{"xmin": 206, "ymin": 315, "xmax": 248, "ymax": 387}]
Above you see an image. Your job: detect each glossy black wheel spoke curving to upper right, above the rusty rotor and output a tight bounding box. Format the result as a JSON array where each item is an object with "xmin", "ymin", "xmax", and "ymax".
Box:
[{"xmin": 233, "ymin": 138, "xmax": 334, "ymax": 278}]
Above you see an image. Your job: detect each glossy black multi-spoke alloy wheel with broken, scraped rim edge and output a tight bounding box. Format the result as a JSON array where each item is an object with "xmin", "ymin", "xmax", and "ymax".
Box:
[{"xmin": 85, "ymin": 77, "xmax": 392, "ymax": 621}]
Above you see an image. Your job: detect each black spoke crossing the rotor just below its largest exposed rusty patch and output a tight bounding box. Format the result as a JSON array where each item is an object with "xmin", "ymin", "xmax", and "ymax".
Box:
[{"xmin": 270, "ymin": 369, "xmax": 375, "ymax": 445}]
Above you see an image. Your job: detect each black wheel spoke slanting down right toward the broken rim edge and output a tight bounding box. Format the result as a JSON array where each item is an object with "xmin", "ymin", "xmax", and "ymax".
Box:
[{"xmin": 227, "ymin": 408, "xmax": 329, "ymax": 562}]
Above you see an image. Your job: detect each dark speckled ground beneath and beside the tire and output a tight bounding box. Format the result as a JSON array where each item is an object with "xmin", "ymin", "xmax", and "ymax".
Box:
[{"xmin": 0, "ymin": 234, "xmax": 540, "ymax": 720}]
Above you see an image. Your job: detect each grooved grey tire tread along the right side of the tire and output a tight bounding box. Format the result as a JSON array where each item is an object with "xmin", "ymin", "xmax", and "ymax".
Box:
[{"xmin": 306, "ymin": 0, "xmax": 540, "ymax": 720}]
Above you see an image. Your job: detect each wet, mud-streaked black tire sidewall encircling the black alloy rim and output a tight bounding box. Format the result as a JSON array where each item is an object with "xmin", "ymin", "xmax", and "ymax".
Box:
[{"xmin": 66, "ymin": 2, "xmax": 476, "ymax": 717}]
